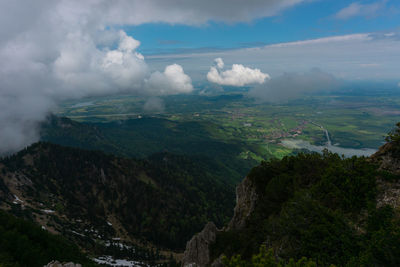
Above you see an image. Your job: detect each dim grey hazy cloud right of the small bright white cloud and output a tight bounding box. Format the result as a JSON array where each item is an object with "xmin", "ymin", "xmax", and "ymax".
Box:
[{"xmin": 249, "ymin": 69, "xmax": 339, "ymax": 102}]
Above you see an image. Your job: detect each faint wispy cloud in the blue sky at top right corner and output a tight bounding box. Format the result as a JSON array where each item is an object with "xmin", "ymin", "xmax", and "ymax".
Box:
[{"xmin": 335, "ymin": 0, "xmax": 387, "ymax": 19}]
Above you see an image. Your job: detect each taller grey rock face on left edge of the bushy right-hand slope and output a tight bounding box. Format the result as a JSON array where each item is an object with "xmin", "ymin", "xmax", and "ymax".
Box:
[{"xmin": 227, "ymin": 177, "xmax": 258, "ymax": 230}]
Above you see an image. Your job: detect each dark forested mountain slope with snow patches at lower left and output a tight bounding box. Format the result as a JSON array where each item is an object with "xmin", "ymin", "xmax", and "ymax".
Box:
[{"xmin": 0, "ymin": 143, "xmax": 234, "ymax": 253}]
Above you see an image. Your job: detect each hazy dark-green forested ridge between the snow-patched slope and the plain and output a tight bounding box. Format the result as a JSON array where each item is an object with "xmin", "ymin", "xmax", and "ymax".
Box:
[{"xmin": 41, "ymin": 116, "xmax": 257, "ymax": 185}]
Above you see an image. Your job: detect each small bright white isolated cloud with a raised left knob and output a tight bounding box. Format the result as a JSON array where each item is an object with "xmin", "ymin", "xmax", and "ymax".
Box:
[{"xmin": 207, "ymin": 58, "xmax": 270, "ymax": 86}]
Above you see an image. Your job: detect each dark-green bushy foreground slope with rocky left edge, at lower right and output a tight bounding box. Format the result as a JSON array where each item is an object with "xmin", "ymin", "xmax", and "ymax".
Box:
[{"xmin": 184, "ymin": 148, "xmax": 400, "ymax": 266}]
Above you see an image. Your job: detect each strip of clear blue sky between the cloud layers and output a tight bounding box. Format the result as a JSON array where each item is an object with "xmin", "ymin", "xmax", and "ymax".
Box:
[{"xmin": 126, "ymin": 0, "xmax": 400, "ymax": 55}]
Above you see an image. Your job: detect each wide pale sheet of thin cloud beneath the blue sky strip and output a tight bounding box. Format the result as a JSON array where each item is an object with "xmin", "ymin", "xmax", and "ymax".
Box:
[{"xmin": 147, "ymin": 32, "xmax": 400, "ymax": 81}]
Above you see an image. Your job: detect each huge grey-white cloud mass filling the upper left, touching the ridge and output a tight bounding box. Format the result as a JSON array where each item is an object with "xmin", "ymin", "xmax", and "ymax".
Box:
[{"xmin": 0, "ymin": 0, "xmax": 199, "ymax": 155}]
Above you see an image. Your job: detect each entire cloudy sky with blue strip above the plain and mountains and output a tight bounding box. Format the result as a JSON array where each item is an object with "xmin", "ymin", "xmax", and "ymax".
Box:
[{"xmin": 0, "ymin": 0, "xmax": 400, "ymax": 154}]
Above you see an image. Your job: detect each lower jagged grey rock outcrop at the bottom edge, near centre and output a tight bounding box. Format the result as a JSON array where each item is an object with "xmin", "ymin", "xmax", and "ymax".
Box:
[{"xmin": 182, "ymin": 222, "xmax": 218, "ymax": 267}]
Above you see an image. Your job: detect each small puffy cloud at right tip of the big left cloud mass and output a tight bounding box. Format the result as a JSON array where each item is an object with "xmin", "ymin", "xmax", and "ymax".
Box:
[{"xmin": 146, "ymin": 64, "xmax": 193, "ymax": 95}]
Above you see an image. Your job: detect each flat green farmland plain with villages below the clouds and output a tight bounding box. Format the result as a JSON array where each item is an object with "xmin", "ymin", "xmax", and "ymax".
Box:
[{"xmin": 57, "ymin": 92, "xmax": 400, "ymax": 161}]
